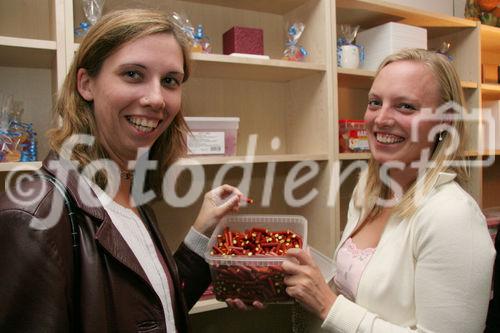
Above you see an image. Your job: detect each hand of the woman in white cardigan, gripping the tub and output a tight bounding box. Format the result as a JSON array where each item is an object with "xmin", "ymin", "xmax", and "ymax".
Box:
[{"xmin": 282, "ymin": 249, "xmax": 337, "ymax": 320}]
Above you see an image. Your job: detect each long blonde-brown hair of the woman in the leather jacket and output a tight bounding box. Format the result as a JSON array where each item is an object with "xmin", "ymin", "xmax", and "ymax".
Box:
[{"xmin": 48, "ymin": 9, "xmax": 191, "ymax": 196}]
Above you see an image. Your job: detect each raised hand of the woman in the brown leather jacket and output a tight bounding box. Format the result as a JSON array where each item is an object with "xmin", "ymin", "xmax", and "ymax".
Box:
[{"xmin": 193, "ymin": 184, "xmax": 243, "ymax": 237}]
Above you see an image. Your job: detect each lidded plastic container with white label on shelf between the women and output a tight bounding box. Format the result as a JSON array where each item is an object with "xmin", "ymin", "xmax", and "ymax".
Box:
[{"xmin": 184, "ymin": 117, "xmax": 240, "ymax": 156}]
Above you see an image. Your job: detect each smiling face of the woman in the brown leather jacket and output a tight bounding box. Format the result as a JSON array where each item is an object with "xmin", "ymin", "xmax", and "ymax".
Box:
[{"xmin": 78, "ymin": 33, "xmax": 184, "ymax": 167}]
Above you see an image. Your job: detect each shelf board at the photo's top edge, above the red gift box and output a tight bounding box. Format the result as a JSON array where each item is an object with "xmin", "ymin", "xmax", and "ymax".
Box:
[{"xmin": 176, "ymin": 0, "xmax": 309, "ymax": 15}]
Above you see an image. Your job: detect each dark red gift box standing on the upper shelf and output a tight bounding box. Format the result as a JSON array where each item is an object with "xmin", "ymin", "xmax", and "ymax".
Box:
[{"xmin": 222, "ymin": 27, "xmax": 264, "ymax": 55}]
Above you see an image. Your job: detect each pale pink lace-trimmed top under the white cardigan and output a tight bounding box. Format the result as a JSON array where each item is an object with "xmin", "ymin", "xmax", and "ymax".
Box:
[{"xmin": 333, "ymin": 237, "xmax": 375, "ymax": 301}]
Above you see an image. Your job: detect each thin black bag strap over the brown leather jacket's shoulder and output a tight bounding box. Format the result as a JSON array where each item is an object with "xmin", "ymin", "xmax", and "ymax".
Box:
[{"xmin": 35, "ymin": 173, "xmax": 80, "ymax": 332}]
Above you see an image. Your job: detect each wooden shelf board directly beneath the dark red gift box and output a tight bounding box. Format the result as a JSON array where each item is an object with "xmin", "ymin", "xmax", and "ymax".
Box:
[{"xmin": 191, "ymin": 53, "xmax": 326, "ymax": 82}]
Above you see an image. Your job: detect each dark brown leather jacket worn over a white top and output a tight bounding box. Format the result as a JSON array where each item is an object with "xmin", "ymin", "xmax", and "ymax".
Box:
[{"xmin": 0, "ymin": 153, "xmax": 210, "ymax": 333}]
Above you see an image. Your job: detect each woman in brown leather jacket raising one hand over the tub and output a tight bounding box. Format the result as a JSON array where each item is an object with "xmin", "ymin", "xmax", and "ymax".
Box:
[{"xmin": 0, "ymin": 10, "xmax": 241, "ymax": 333}]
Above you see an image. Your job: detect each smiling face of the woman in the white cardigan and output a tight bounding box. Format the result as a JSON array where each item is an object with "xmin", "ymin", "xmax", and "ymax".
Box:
[{"xmin": 365, "ymin": 61, "xmax": 441, "ymax": 164}]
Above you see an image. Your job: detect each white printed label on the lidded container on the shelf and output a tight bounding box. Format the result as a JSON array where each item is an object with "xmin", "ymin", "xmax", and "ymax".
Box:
[{"xmin": 187, "ymin": 132, "xmax": 226, "ymax": 155}]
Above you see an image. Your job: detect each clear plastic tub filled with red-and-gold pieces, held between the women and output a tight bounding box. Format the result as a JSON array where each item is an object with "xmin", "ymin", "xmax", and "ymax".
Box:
[{"xmin": 205, "ymin": 215, "xmax": 307, "ymax": 303}]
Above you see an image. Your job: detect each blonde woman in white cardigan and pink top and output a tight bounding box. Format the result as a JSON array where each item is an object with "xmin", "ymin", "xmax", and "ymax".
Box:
[{"xmin": 283, "ymin": 49, "xmax": 495, "ymax": 333}]
